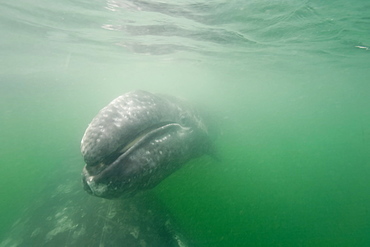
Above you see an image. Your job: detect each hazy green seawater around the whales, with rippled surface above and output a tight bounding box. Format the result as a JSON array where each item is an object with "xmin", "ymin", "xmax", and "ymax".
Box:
[{"xmin": 0, "ymin": 0, "xmax": 370, "ymax": 246}]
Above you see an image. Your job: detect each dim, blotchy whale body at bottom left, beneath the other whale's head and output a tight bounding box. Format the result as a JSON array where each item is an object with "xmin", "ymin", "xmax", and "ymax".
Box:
[{"xmin": 0, "ymin": 157, "xmax": 189, "ymax": 247}]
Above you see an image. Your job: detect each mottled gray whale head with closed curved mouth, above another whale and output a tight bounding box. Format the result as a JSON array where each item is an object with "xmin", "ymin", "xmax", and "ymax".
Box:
[{"xmin": 81, "ymin": 91, "xmax": 210, "ymax": 198}]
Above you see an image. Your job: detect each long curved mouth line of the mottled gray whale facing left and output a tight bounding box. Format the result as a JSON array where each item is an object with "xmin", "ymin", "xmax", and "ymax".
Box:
[{"xmin": 84, "ymin": 122, "xmax": 182, "ymax": 177}]
